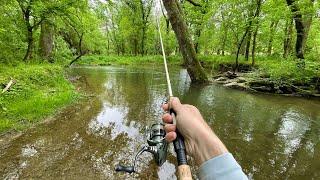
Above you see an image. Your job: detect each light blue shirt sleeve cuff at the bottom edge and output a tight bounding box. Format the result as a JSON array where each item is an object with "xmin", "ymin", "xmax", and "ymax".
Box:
[{"xmin": 199, "ymin": 153, "xmax": 248, "ymax": 180}]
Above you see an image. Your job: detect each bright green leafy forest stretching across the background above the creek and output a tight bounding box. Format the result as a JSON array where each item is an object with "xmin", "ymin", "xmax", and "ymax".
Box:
[{"xmin": 0, "ymin": 0, "xmax": 320, "ymax": 64}]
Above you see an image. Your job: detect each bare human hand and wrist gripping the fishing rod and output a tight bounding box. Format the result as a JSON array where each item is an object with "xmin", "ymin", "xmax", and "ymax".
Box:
[{"xmin": 162, "ymin": 97, "xmax": 228, "ymax": 165}]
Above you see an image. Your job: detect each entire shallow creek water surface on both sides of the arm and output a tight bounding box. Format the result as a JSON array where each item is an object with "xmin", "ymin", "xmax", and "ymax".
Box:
[{"xmin": 0, "ymin": 67, "xmax": 320, "ymax": 179}]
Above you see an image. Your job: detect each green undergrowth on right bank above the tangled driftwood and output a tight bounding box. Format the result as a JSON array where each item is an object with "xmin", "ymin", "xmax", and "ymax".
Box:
[{"xmin": 199, "ymin": 56, "xmax": 320, "ymax": 85}]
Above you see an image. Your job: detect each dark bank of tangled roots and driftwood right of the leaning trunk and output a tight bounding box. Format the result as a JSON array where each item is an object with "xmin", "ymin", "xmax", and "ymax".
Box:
[{"xmin": 213, "ymin": 64, "xmax": 320, "ymax": 99}]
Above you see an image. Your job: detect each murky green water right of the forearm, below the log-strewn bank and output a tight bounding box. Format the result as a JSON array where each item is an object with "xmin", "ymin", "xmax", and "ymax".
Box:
[{"xmin": 182, "ymin": 79, "xmax": 320, "ymax": 179}]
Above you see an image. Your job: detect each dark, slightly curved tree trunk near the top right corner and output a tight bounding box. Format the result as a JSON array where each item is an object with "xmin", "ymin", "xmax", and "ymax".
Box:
[{"xmin": 286, "ymin": 0, "xmax": 305, "ymax": 59}]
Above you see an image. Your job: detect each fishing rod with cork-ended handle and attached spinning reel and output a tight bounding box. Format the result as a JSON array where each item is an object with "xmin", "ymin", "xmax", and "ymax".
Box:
[{"xmin": 115, "ymin": 0, "xmax": 192, "ymax": 180}]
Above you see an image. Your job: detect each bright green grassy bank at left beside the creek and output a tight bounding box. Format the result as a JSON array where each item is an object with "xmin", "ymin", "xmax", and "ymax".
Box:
[{"xmin": 0, "ymin": 64, "xmax": 78, "ymax": 133}]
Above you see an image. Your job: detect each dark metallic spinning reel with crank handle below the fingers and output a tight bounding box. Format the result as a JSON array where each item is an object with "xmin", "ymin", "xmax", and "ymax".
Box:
[{"xmin": 115, "ymin": 123, "xmax": 168, "ymax": 173}]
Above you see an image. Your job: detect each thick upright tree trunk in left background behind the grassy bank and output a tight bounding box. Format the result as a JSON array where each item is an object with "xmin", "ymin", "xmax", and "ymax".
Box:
[{"xmin": 39, "ymin": 20, "xmax": 54, "ymax": 63}]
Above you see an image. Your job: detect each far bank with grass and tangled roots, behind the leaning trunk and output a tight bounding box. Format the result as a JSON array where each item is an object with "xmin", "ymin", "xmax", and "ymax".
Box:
[{"xmin": 77, "ymin": 55, "xmax": 320, "ymax": 97}]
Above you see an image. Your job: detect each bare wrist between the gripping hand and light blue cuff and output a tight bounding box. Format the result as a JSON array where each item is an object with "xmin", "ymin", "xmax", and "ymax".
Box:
[{"xmin": 194, "ymin": 127, "xmax": 228, "ymax": 166}]
